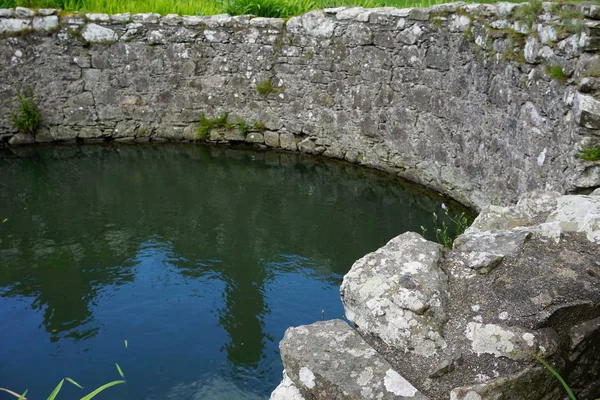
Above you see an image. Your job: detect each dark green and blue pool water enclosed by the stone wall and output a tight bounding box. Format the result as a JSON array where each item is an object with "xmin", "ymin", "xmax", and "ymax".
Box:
[{"xmin": 0, "ymin": 145, "xmax": 464, "ymax": 400}]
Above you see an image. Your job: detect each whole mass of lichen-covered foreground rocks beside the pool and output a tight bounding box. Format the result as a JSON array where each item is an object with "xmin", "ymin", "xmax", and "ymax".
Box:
[{"xmin": 281, "ymin": 191, "xmax": 600, "ymax": 400}]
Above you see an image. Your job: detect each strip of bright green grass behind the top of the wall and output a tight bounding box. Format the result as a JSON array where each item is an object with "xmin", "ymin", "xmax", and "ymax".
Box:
[{"xmin": 0, "ymin": 0, "xmax": 536, "ymax": 18}]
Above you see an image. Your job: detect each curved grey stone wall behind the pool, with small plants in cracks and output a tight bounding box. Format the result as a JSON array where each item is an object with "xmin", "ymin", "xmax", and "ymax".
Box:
[{"xmin": 0, "ymin": 3, "xmax": 600, "ymax": 208}]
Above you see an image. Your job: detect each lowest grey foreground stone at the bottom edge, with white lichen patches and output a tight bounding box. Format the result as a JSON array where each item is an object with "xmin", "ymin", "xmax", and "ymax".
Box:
[{"xmin": 279, "ymin": 320, "xmax": 426, "ymax": 400}]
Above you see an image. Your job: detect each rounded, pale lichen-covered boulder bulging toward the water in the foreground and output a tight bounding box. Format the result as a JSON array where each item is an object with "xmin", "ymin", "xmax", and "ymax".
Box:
[{"xmin": 340, "ymin": 233, "xmax": 447, "ymax": 357}]
